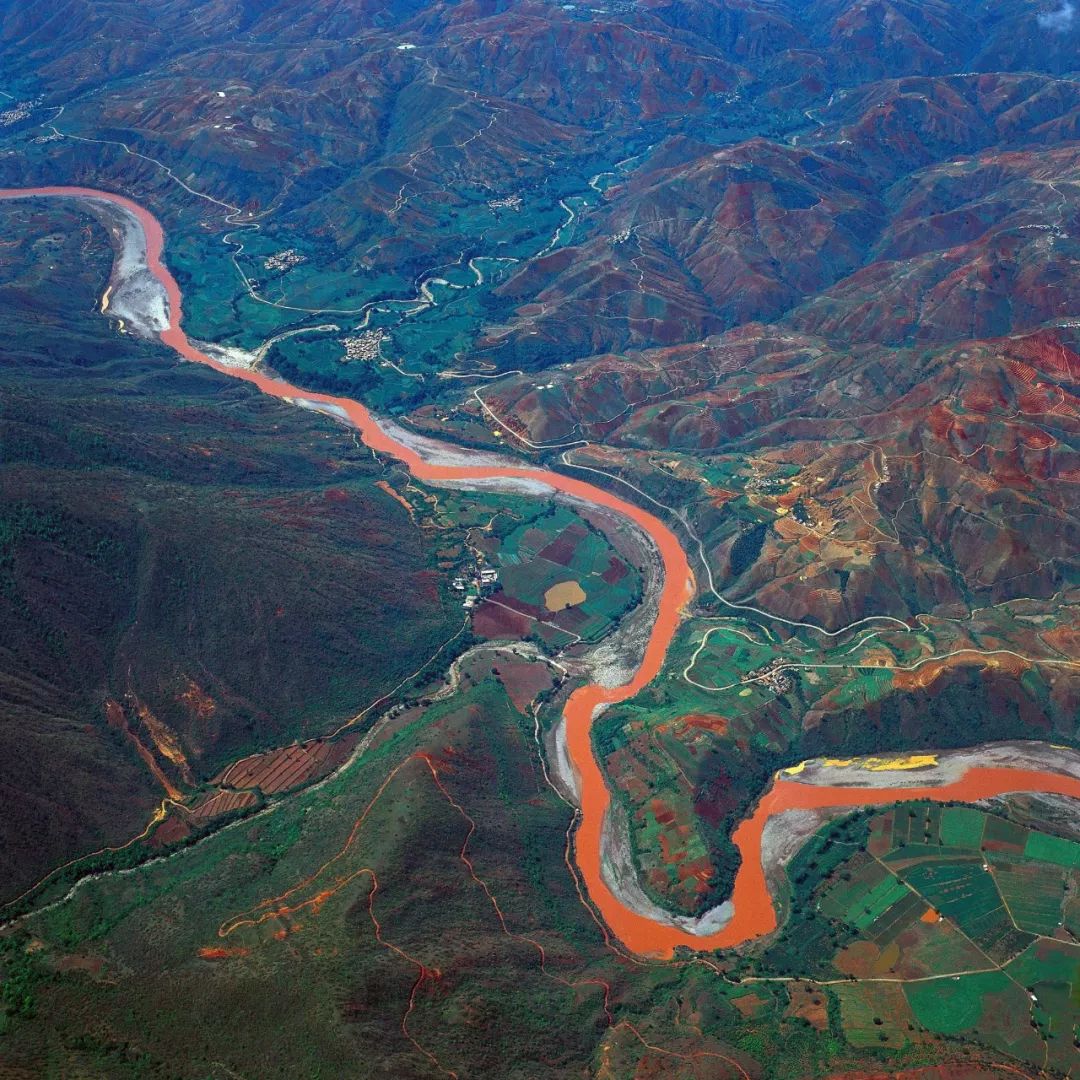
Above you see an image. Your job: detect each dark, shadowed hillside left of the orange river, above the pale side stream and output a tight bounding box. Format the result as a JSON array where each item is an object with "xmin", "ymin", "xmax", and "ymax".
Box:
[{"xmin": 0, "ymin": 204, "xmax": 459, "ymax": 893}]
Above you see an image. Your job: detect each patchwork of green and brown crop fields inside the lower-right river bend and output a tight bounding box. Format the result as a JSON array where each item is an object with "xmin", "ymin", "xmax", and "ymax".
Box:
[{"xmin": 767, "ymin": 802, "xmax": 1080, "ymax": 1071}]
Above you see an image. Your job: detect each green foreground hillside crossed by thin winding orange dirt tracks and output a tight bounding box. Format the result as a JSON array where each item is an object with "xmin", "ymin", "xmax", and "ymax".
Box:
[{"xmin": 0, "ymin": 665, "xmax": 954, "ymax": 1080}]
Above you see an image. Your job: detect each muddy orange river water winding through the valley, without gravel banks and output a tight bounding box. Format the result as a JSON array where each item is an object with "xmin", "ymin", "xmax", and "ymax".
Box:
[{"xmin": 6, "ymin": 187, "xmax": 1080, "ymax": 957}]
